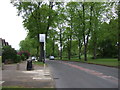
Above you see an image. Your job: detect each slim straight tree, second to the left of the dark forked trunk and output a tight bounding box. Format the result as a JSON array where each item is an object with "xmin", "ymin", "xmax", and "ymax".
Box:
[{"xmin": 66, "ymin": 2, "xmax": 77, "ymax": 60}]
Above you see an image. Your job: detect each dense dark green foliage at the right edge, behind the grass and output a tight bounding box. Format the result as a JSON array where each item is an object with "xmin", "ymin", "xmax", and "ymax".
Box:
[{"xmin": 89, "ymin": 19, "xmax": 118, "ymax": 57}]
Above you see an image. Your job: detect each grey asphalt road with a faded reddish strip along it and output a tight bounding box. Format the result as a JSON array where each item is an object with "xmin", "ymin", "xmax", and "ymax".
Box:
[{"xmin": 46, "ymin": 60, "xmax": 118, "ymax": 88}]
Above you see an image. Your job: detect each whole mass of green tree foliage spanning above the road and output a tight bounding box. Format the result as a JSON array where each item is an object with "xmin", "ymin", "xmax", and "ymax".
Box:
[{"xmin": 13, "ymin": 1, "xmax": 118, "ymax": 58}]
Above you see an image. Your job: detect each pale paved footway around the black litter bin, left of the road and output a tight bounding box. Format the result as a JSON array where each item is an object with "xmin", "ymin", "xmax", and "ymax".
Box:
[{"xmin": 2, "ymin": 61, "xmax": 54, "ymax": 88}]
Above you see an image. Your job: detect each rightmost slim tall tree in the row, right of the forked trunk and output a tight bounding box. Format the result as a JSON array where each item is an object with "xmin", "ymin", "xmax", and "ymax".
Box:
[{"xmin": 90, "ymin": 2, "xmax": 105, "ymax": 59}]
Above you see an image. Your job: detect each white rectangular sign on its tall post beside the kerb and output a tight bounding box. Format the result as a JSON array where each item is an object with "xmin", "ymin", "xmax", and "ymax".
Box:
[{"xmin": 39, "ymin": 34, "xmax": 45, "ymax": 63}]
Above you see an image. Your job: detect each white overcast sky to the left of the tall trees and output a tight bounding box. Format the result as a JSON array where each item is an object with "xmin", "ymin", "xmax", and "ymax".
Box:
[{"xmin": 0, "ymin": 0, "xmax": 27, "ymax": 50}]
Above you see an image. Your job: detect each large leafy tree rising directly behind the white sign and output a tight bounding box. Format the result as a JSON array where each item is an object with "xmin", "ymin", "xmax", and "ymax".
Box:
[{"xmin": 12, "ymin": 1, "xmax": 56, "ymax": 61}]
